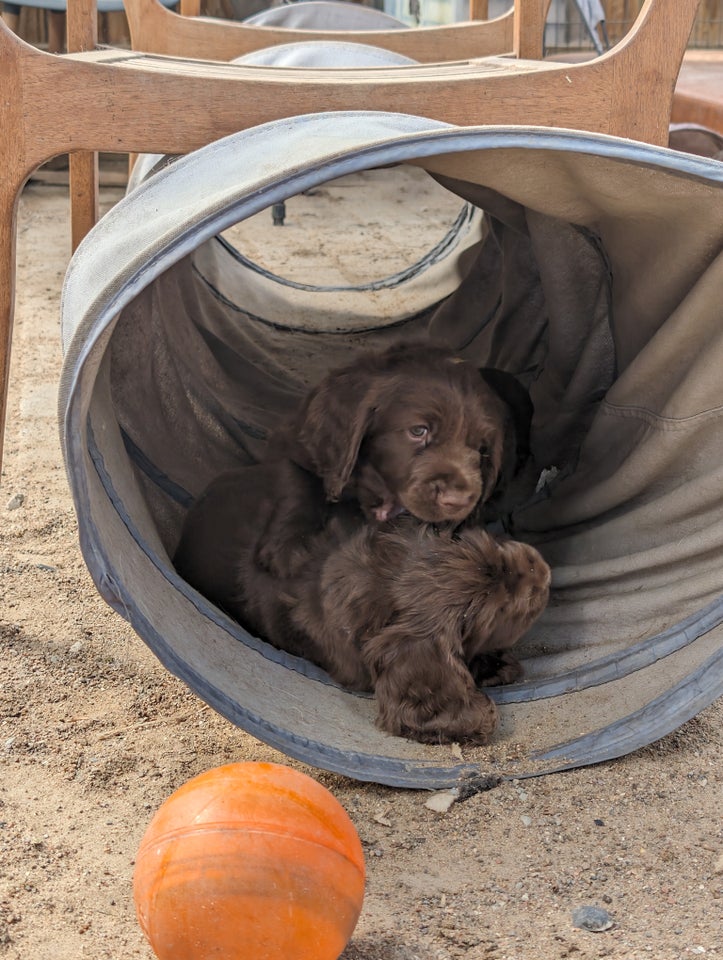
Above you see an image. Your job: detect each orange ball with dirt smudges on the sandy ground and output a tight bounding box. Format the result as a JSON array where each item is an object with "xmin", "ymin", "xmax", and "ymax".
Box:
[{"xmin": 133, "ymin": 763, "xmax": 365, "ymax": 960}]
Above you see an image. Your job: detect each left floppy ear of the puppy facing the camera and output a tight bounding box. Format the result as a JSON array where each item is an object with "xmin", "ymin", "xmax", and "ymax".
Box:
[{"xmin": 295, "ymin": 369, "xmax": 376, "ymax": 500}]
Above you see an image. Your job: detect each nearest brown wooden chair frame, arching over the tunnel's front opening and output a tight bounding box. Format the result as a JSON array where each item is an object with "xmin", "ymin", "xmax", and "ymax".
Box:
[{"xmin": 0, "ymin": 0, "xmax": 699, "ymax": 478}]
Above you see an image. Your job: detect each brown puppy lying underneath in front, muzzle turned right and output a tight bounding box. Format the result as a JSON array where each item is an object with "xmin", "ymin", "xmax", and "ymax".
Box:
[{"xmin": 292, "ymin": 521, "xmax": 550, "ymax": 743}]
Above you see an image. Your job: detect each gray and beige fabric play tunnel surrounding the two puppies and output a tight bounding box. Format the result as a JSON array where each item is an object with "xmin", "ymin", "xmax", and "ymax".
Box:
[{"xmin": 60, "ymin": 112, "xmax": 723, "ymax": 788}]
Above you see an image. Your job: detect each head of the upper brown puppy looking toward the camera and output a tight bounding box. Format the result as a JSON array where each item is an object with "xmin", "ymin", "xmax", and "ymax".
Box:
[{"xmin": 270, "ymin": 343, "xmax": 531, "ymax": 523}]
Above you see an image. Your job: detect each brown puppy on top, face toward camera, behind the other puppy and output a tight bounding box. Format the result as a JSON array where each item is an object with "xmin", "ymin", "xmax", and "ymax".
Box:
[{"xmin": 174, "ymin": 343, "xmax": 540, "ymax": 738}]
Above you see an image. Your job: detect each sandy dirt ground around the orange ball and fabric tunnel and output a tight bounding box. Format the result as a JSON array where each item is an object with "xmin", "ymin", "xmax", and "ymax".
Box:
[{"xmin": 0, "ymin": 172, "xmax": 723, "ymax": 960}]
